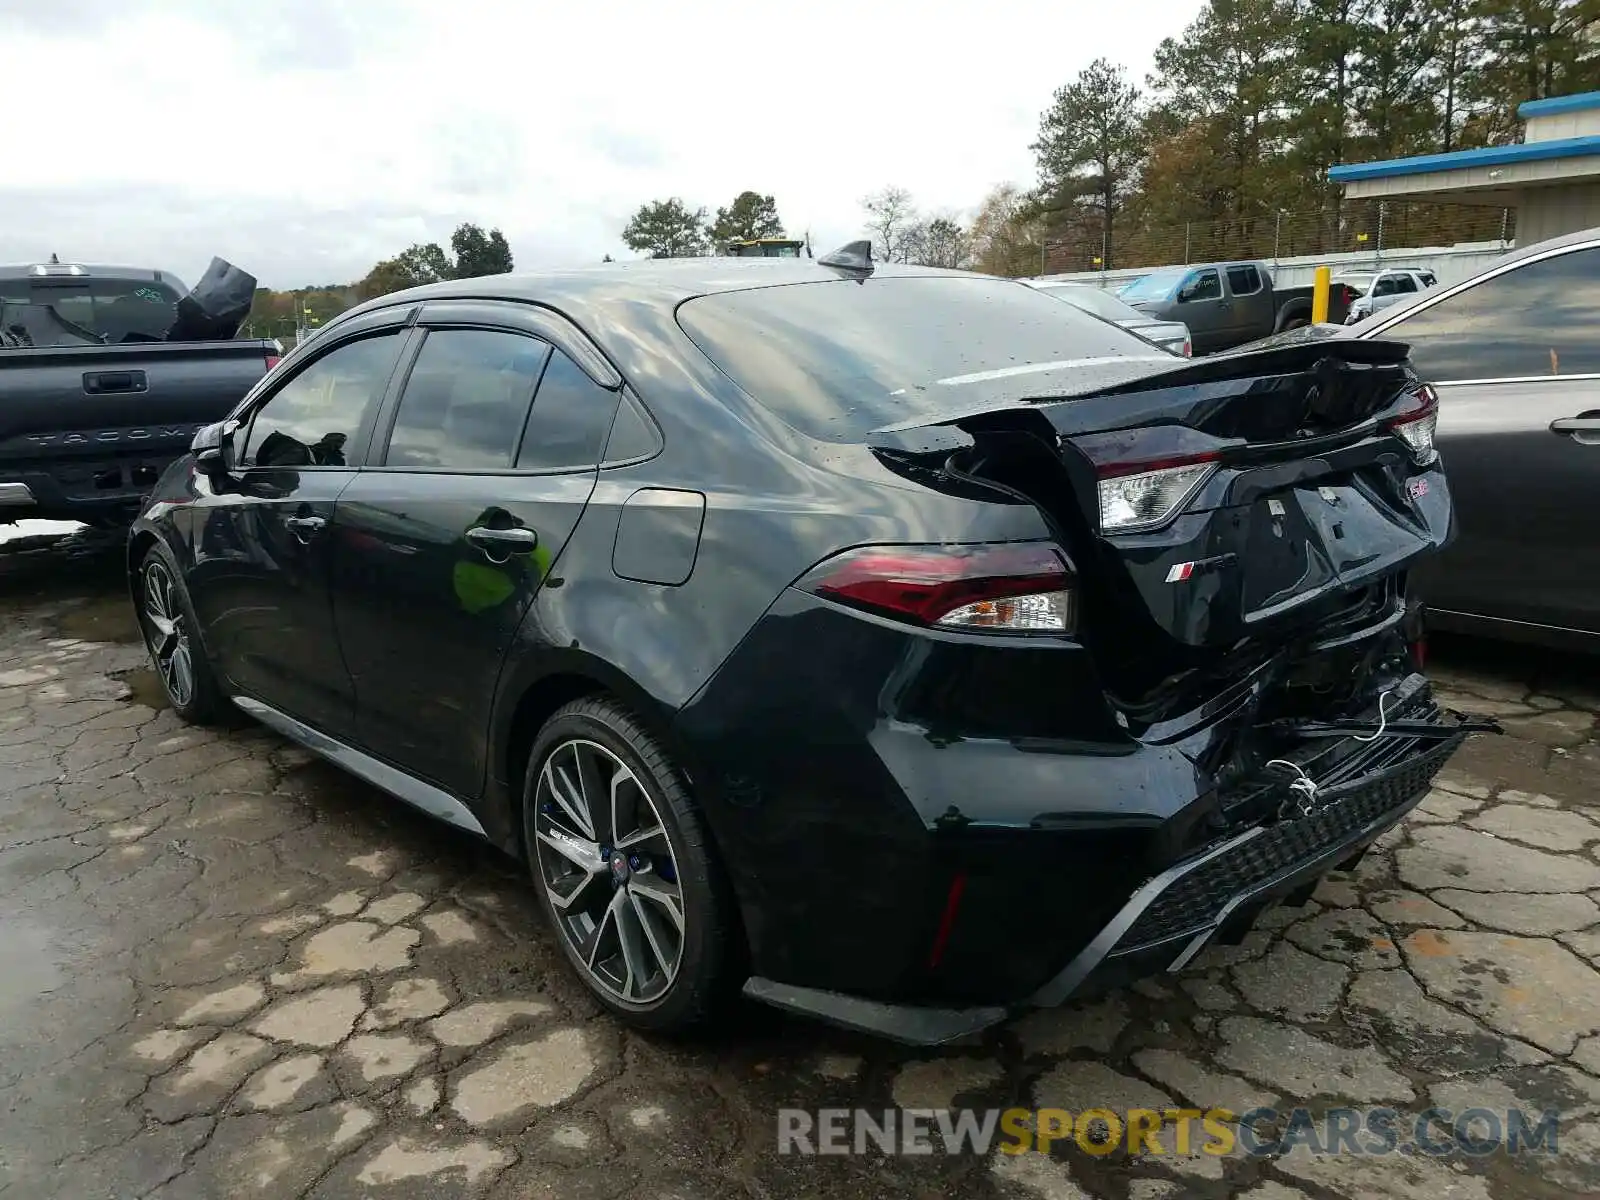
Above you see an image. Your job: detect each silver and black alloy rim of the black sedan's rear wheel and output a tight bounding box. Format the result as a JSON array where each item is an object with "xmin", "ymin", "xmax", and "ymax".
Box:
[{"xmin": 533, "ymin": 738, "xmax": 685, "ymax": 1006}]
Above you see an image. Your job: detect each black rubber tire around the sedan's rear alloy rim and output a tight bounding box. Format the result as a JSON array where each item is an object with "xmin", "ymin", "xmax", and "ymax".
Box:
[{"xmin": 522, "ymin": 696, "xmax": 739, "ymax": 1034}]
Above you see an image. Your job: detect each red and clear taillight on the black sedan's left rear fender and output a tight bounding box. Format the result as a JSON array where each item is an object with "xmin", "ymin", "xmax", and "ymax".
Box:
[{"xmin": 798, "ymin": 542, "xmax": 1075, "ymax": 634}]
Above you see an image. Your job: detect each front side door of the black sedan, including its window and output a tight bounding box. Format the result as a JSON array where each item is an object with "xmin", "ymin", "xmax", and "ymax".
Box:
[{"xmin": 192, "ymin": 314, "xmax": 405, "ymax": 736}]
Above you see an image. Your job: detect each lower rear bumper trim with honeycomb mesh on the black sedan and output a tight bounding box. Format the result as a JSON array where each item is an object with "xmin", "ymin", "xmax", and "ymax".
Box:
[{"xmin": 744, "ymin": 709, "xmax": 1480, "ymax": 1045}]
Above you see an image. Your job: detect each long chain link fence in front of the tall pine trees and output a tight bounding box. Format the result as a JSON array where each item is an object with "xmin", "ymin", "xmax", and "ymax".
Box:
[{"xmin": 1038, "ymin": 200, "xmax": 1517, "ymax": 275}]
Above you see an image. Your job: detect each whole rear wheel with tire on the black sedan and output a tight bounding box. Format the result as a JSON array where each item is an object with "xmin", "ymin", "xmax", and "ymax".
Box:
[{"xmin": 523, "ymin": 699, "xmax": 734, "ymax": 1032}]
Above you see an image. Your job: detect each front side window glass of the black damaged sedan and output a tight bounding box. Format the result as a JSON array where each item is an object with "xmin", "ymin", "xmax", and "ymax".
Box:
[{"xmin": 238, "ymin": 330, "xmax": 400, "ymax": 467}]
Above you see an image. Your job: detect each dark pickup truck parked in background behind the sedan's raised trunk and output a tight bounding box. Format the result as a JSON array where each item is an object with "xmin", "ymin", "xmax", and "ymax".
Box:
[{"xmin": 1117, "ymin": 262, "xmax": 1354, "ymax": 354}]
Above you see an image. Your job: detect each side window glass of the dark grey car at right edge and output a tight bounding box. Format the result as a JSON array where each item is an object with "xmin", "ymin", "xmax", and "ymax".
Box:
[{"xmin": 1379, "ymin": 248, "xmax": 1600, "ymax": 382}]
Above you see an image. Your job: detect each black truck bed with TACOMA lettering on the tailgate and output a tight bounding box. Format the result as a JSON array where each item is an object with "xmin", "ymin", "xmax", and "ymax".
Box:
[{"xmin": 0, "ymin": 339, "xmax": 280, "ymax": 523}]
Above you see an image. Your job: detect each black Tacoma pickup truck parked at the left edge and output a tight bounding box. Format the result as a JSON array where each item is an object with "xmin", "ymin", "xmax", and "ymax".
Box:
[{"xmin": 0, "ymin": 261, "xmax": 282, "ymax": 526}]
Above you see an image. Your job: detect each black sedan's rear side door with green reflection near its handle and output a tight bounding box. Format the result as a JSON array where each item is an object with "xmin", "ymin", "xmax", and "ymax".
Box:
[{"xmin": 333, "ymin": 301, "xmax": 621, "ymax": 800}]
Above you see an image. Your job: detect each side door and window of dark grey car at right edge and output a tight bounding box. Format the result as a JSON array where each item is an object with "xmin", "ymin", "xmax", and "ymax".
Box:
[{"xmin": 1363, "ymin": 243, "xmax": 1600, "ymax": 632}]
